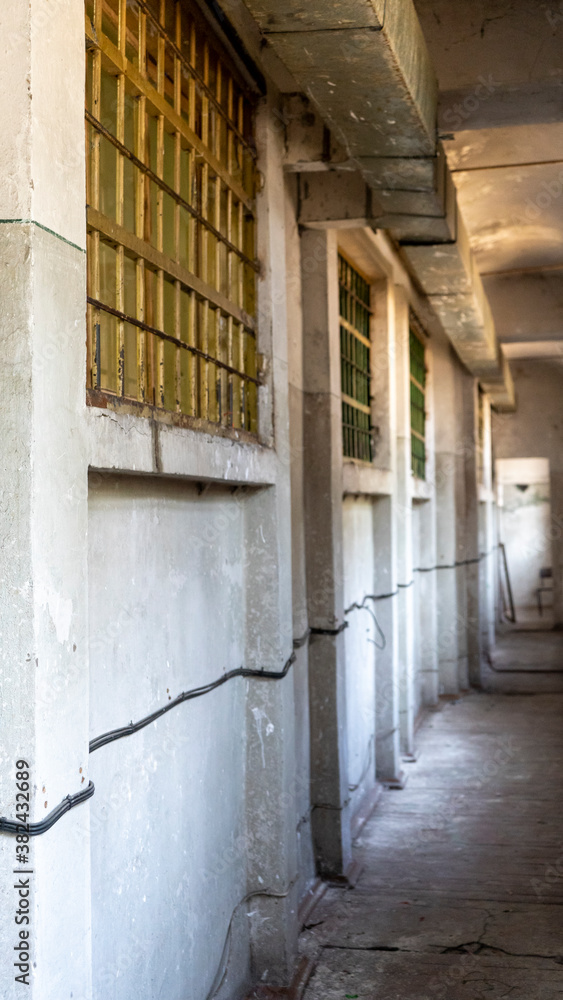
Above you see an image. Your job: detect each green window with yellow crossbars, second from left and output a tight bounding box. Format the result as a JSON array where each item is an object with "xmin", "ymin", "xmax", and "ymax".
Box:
[{"xmin": 338, "ymin": 254, "xmax": 373, "ymax": 462}]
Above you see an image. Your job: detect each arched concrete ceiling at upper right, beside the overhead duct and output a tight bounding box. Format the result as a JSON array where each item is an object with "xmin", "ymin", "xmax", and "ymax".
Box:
[{"xmin": 414, "ymin": 0, "xmax": 563, "ymax": 357}]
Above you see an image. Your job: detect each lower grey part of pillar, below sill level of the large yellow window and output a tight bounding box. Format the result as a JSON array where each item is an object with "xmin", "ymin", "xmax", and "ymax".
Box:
[{"xmin": 245, "ymin": 489, "xmax": 298, "ymax": 986}]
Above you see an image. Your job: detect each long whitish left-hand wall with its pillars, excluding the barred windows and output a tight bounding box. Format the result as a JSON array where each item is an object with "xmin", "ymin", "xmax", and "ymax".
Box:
[{"xmin": 0, "ymin": 0, "xmax": 496, "ymax": 1000}]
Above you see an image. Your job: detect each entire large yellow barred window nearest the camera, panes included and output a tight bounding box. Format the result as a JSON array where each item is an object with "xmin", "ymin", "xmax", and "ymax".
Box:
[{"xmin": 86, "ymin": 0, "xmax": 258, "ymax": 433}]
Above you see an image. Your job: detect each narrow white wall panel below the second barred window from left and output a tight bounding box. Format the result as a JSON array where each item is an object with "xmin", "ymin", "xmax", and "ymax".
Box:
[{"xmin": 343, "ymin": 497, "xmax": 381, "ymax": 815}]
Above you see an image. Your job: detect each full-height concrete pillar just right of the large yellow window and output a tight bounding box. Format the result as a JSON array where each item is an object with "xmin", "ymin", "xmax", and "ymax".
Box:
[{"xmin": 245, "ymin": 95, "xmax": 298, "ymax": 986}]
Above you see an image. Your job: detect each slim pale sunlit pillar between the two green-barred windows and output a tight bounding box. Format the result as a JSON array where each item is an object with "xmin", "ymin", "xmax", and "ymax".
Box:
[{"xmin": 394, "ymin": 286, "xmax": 414, "ymax": 756}]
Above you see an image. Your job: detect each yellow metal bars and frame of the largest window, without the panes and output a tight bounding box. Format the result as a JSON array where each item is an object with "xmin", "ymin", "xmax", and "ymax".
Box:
[{"xmin": 85, "ymin": 0, "xmax": 261, "ymax": 442}]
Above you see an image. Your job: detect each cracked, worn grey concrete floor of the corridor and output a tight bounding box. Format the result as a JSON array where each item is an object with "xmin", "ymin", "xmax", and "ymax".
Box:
[{"xmin": 301, "ymin": 693, "xmax": 563, "ymax": 1000}]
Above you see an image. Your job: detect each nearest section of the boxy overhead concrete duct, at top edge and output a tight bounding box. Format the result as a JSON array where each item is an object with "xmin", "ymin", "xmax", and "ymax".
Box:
[{"xmin": 241, "ymin": 0, "xmax": 437, "ymax": 156}]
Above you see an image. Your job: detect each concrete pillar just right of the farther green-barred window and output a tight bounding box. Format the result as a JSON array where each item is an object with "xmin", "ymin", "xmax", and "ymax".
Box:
[{"xmin": 433, "ymin": 344, "xmax": 459, "ymax": 694}]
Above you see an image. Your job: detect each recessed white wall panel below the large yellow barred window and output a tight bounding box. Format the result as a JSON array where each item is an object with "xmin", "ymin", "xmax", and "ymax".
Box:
[{"xmin": 89, "ymin": 477, "xmax": 251, "ymax": 1000}]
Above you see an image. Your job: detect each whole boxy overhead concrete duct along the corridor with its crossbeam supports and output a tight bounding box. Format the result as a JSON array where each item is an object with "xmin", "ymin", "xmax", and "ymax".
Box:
[{"xmin": 246, "ymin": 0, "xmax": 508, "ymax": 394}]
